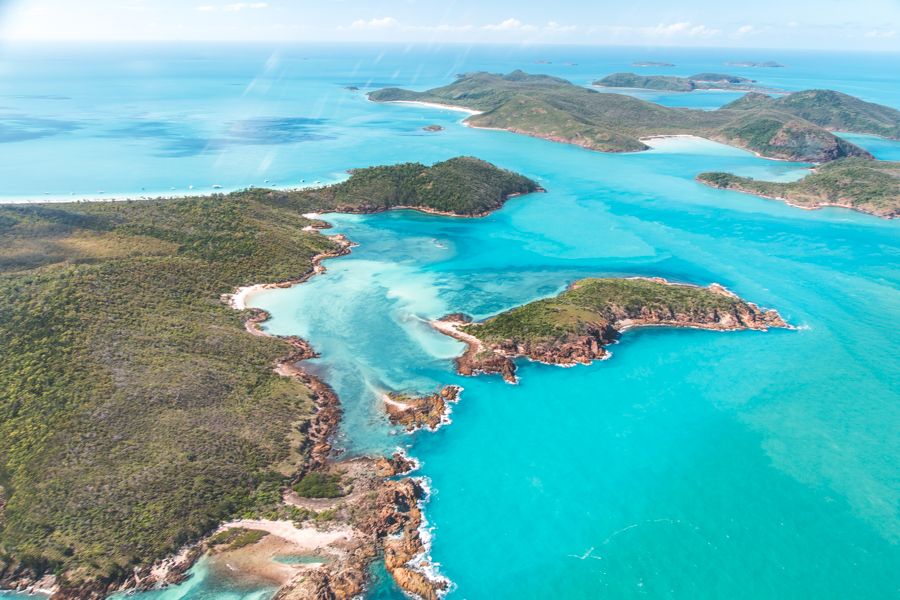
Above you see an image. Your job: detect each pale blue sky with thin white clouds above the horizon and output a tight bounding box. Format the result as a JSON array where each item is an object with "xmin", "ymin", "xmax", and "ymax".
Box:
[{"xmin": 0, "ymin": 0, "xmax": 900, "ymax": 51}]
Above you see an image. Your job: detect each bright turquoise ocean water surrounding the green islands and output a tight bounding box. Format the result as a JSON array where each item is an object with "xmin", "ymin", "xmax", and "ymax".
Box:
[{"xmin": 0, "ymin": 45, "xmax": 900, "ymax": 600}]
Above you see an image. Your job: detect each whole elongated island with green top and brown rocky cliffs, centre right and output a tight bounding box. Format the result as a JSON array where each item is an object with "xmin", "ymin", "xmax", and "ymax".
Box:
[{"xmin": 432, "ymin": 278, "xmax": 788, "ymax": 383}]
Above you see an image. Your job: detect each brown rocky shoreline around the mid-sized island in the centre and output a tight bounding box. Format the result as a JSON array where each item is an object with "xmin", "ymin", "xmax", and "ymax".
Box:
[{"xmin": 431, "ymin": 278, "xmax": 790, "ymax": 383}]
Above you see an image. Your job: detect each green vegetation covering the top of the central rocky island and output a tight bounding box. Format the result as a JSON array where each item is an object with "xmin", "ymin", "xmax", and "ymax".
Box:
[{"xmin": 466, "ymin": 279, "xmax": 764, "ymax": 344}]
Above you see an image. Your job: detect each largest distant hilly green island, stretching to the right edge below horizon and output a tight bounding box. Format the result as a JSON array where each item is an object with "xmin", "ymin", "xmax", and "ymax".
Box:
[{"xmin": 369, "ymin": 71, "xmax": 900, "ymax": 163}]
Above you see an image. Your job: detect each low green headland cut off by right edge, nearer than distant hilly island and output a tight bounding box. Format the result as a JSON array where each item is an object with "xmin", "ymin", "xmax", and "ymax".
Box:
[{"xmin": 697, "ymin": 158, "xmax": 900, "ymax": 218}]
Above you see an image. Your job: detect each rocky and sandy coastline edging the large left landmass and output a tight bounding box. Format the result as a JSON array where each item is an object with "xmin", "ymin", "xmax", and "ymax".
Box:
[{"xmin": 3, "ymin": 200, "xmax": 464, "ymax": 600}]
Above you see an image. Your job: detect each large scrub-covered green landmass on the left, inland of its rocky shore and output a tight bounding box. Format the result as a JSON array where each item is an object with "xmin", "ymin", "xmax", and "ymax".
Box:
[{"xmin": 0, "ymin": 158, "xmax": 539, "ymax": 598}]
